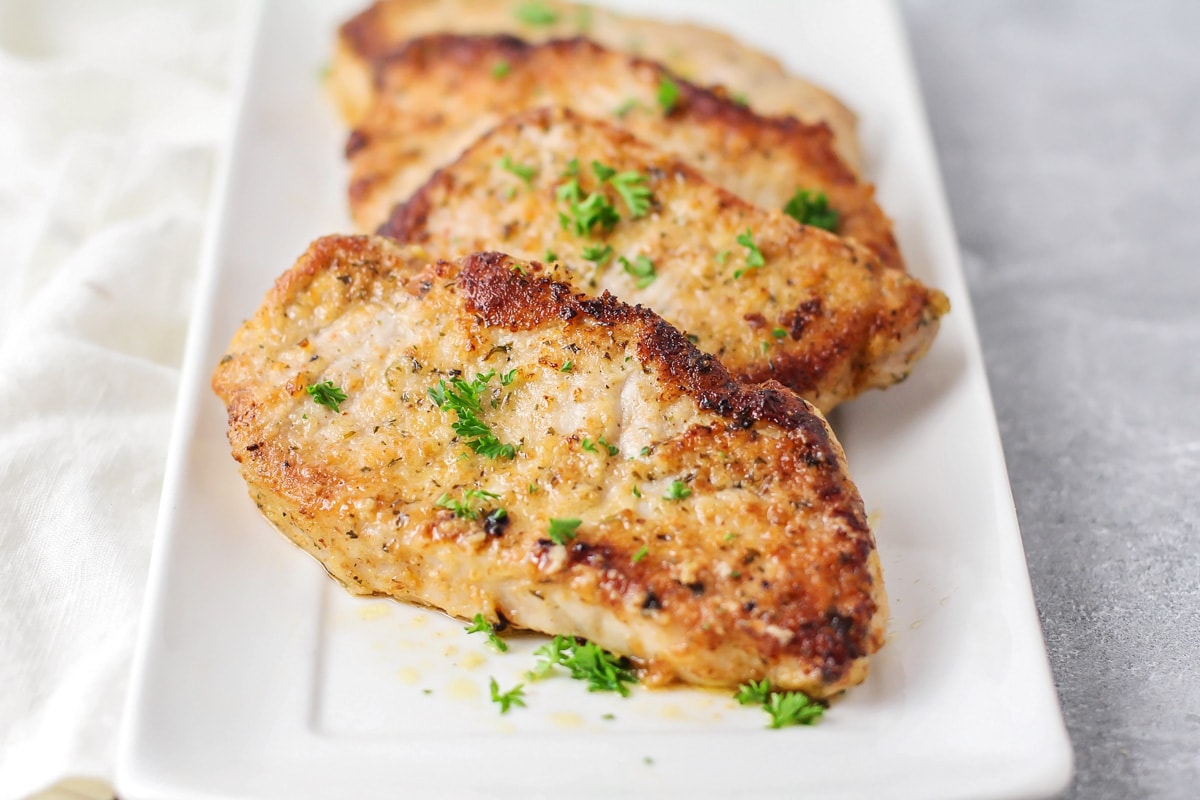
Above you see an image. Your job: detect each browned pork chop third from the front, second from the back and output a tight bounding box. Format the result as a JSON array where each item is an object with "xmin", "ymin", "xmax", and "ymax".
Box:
[{"xmin": 346, "ymin": 36, "xmax": 902, "ymax": 267}]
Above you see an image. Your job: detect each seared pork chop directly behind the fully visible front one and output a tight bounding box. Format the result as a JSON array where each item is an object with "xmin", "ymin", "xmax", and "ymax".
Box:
[{"xmin": 379, "ymin": 109, "xmax": 948, "ymax": 411}]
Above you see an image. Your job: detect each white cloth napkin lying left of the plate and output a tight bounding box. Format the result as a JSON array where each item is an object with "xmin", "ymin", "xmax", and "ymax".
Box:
[{"xmin": 0, "ymin": 0, "xmax": 247, "ymax": 800}]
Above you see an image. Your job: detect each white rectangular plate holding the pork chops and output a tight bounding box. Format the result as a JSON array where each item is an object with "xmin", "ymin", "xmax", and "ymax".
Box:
[{"xmin": 118, "ymin": 0, "xmax": 1072, "ymax": 800}]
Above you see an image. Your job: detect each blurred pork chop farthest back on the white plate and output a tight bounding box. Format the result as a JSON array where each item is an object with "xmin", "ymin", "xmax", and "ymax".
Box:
[{"xmin": 329, "ymin": 0, "xmax": 859, "ymax": 169}]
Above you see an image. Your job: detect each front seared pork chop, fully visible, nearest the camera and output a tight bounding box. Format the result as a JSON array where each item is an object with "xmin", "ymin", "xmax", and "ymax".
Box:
[{"xmin": 212, "ymin": 236, "xmax": 886, "ymax": 697}]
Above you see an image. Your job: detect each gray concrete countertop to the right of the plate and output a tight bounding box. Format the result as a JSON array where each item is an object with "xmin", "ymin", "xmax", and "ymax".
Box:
[{"xmin": 901, "ymin": 0, "xmax": 1200, "ymax": 800}]
